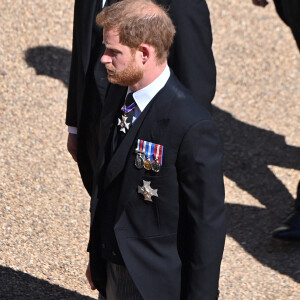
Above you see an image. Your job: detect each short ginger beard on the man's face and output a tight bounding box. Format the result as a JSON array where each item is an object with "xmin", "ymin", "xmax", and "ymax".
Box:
[{"xmin": 107, "ymin": 56, "xmax": 144, "ymax": 86}]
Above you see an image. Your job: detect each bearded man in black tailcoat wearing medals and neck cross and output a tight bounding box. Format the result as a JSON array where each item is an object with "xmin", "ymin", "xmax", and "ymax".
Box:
[{"xmin": 83, "ymin": 0, "xmax": 226, "ymax": 300}]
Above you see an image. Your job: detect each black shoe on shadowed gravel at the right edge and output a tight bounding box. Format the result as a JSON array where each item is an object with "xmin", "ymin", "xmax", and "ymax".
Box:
[{"xmin": 272, "ymin": 210, "xmax": 300, "ymax": 242}]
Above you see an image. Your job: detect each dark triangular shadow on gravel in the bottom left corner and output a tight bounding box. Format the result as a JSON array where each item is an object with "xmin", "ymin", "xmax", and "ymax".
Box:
[{"xmin": 0, "ymin": 266, "xmax": 94, "ymax": 300}]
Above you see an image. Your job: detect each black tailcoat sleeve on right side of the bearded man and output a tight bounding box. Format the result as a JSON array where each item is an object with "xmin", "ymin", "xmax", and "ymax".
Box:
[{"xmin": 177, "ymin": 120, "xmax": 226, "ymax": 300}]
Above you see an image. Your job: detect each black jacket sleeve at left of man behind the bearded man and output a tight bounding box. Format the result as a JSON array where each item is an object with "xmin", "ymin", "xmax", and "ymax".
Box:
[{"xmin": 66, "ymin": 1, "xmax": 79, "ymax": 127}]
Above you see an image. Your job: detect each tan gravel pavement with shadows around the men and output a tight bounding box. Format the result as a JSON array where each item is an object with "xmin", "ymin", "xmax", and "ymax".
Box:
[{"xmin": 0, "ymin": 0, "xmax": 300, "ymax": 300}]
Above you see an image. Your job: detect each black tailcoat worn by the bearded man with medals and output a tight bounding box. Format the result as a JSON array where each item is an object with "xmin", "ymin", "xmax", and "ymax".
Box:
[{"xmin": 89, "ymin": 74, "xmax": 225, "ymax": 300}]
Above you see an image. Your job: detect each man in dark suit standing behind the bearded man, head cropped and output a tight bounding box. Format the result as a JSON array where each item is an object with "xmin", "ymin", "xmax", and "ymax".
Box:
[{"xmin": 66, "ymin": 0, "xmax": 216, "ymax": 193}]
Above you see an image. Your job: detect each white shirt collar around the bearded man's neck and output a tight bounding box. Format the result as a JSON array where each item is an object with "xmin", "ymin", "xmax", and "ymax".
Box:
[{"xmin": 127, "ymin": 65, "xmax": 171, "ymax": 112}]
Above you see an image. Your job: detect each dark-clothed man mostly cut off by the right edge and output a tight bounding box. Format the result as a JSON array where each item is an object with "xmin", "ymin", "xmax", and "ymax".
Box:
[{"xmin": 252, "ymin": 0, "xmax": 300, "ymax": 242}]
